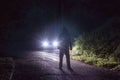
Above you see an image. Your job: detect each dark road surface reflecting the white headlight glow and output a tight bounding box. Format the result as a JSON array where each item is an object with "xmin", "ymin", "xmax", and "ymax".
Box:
[{"xmin": 12, "ymin": 51, "xmax": 120, "ymax": 80}]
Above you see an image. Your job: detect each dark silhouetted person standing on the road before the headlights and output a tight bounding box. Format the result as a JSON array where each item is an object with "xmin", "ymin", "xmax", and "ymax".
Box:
[{"xmin": 59, "ymin": 27, "xmax": 72, "ymax": 69}]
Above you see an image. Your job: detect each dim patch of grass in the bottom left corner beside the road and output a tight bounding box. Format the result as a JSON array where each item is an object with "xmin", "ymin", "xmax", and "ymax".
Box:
[{"xmin": 0, "ymin": 57, "xmax": 15, "ymax": 80}]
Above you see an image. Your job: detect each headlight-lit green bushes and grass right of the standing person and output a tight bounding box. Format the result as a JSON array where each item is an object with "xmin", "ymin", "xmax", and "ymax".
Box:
[{"xmin": 72, "ymin": 25, "xmax": 120, "ymax": 69}]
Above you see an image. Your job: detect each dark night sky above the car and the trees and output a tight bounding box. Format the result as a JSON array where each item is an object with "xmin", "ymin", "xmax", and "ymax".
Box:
[{"xmin": 0, "ymin": 0, "xmax": 120, "ymax": 41}]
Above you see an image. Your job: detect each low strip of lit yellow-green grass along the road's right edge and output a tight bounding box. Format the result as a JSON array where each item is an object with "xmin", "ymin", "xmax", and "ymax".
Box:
[{"xmin": 71, "ymin": 54, "xmax": 120, "ymax": 71}]
